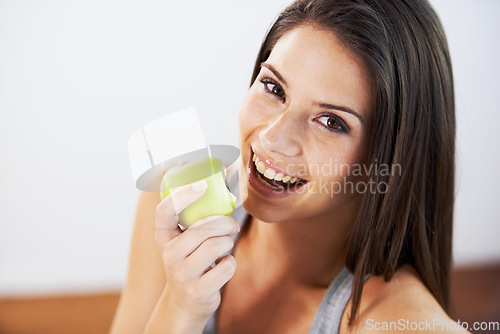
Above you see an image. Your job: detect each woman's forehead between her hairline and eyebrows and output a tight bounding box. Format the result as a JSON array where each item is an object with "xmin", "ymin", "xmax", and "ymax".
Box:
[{"xmin": 266, "ymin": 25, "xmax": 371, "ymax": 116}]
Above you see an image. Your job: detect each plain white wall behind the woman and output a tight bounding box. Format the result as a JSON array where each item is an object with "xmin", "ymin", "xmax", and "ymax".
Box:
[{"xmin": 0, "ymin": 0, "xmax": 500, "ymax": 296}]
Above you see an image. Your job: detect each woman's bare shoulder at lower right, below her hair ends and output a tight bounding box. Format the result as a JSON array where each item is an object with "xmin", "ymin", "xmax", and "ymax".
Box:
[{"xmin": 340, "ymin": 266, "xmax": 468, "ymax": 334}]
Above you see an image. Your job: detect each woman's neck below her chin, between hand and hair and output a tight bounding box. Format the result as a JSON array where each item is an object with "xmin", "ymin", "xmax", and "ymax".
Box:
[{"xmin": 240, "ymin": 200, "xmax": 357, "ymax": 287}]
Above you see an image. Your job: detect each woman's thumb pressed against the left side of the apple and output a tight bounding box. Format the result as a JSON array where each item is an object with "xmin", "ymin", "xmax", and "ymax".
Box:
[{"xmin": 156, "ymin": 180, "xmax": 207, "ymax": 245}]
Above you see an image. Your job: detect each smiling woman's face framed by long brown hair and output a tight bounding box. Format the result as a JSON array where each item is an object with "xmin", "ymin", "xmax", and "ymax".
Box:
[{"xmin": 239, "ymin": 26, "xmax": 372, "ymax": 222}]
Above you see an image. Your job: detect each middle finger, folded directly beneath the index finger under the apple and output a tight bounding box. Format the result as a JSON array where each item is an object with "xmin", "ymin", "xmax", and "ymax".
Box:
[{"xmin": 185, "ymin": 235, "xmax": 234, "ymax": 279}]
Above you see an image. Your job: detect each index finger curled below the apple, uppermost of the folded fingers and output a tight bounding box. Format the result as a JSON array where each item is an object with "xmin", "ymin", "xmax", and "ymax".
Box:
[{"xmin": 168, "ymin": 216, "xmax": 240, "ymax": 258}]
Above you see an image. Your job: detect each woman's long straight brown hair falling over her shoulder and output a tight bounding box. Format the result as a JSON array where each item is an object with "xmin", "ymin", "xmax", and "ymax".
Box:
[{"xmin": 252, "ymin": 0, "xmax": 455, "ymax": 324}]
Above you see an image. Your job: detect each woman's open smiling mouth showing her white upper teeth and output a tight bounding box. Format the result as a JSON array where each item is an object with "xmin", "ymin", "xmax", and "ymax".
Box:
[{"xmin": 249, "ymin": 151, "xmax": 308, "ymax": 192}]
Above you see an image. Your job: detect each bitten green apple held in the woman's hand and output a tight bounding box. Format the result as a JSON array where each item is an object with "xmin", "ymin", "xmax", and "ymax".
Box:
[{"xmin": 160, "ymin": 157, "xmax": 236, "ymax": 228}]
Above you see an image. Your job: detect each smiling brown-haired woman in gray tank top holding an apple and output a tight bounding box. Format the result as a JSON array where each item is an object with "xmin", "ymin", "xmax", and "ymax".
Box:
[{"xmin": 112, "ymin": 0, "xmax": 465, "ymax": 333}]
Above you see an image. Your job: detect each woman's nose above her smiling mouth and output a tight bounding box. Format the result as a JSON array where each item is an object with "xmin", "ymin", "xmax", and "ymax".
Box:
[{"xmin": 259, "ymin": 111, "xmax": 301, "ymax": 157}]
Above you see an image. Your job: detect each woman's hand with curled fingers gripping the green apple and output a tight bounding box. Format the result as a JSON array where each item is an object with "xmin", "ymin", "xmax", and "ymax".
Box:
[{"xmin": 151, "ymin": 181, "xmax": 239, "ymax": 328}]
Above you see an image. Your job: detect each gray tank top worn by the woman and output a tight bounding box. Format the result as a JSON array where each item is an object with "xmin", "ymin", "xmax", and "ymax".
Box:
[{"xmin": 203, "ymin": 173, "xmax": 353, "ymax": 334}]
